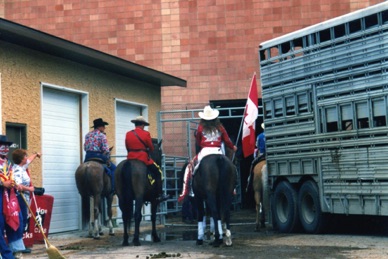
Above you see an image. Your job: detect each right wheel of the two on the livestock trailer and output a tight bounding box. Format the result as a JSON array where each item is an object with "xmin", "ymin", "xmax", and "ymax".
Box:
[{"xmin": 298, "ymin": 181, "xmax": 328, "ymax": 234}]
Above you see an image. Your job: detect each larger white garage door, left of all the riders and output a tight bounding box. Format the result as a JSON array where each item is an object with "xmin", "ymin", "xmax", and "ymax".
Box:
[{"xmin": 42, "ymin": 88, "xmax": 81, "ymax": 233}]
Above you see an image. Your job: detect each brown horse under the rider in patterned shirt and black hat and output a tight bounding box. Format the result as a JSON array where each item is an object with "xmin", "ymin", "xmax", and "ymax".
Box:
[{"xmin": 75, "ymin": 161, "xmax": 114, "ymax": 239}]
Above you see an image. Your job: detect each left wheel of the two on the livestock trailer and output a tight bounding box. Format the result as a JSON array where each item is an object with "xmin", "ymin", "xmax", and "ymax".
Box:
[{"xmin": 272, "ymin": 182, "xmax": 299, "ymax": 233}]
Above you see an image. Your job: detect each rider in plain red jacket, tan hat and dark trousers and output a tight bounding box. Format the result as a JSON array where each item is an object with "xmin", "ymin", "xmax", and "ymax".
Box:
[{"xmin": 125, "ymin": 116, "xmax": 169, "ymax": 202}]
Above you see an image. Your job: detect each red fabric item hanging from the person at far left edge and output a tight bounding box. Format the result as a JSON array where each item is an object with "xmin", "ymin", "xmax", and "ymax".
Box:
[{"xmin": 3, "ymin": 188, "xmax": 20, "ymax": 231}]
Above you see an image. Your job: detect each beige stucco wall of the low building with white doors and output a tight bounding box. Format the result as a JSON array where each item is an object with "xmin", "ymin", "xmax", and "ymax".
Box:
[{"xmin": 0, "ymin": 41, "xmax": 161, "ymax": 185}]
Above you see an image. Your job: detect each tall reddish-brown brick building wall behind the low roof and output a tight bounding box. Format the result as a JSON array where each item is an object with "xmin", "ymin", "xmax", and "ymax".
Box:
[{"xmin": 0, "ymin": 0, "xmax": 383, "ymax": 110}]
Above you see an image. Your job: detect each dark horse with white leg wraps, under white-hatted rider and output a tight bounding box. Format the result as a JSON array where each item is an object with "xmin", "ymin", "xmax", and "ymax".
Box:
[{"xmin": 193, "ymin": 154, "xmax": 236, "ymax": 247}]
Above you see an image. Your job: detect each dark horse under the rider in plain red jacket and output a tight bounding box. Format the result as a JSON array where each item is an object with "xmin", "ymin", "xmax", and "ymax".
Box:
[{"xmin": 115, "ymin": 139, "xmax": 162, "ymax": 246}]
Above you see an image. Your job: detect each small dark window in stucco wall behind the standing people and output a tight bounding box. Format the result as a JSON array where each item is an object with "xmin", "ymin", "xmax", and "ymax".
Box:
[{"xmin": 5, "ymin": 122, "xmax": 27, "ymax": 162}]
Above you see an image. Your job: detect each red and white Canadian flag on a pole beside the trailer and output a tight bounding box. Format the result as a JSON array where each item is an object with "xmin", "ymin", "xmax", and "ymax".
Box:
[{"xmin": 242, "ymin": 73, "xmax": 259, "ymax": 157}]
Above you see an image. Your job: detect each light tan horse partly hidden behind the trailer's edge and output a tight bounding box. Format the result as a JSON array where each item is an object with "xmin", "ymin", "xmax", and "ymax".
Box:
[{"xmin": 253, "ymin": 159, "xmax": 269, "ymax": 231}]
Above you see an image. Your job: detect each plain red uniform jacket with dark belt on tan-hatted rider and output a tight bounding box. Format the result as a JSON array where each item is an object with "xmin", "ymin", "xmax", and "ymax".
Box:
[{"xmin": 125, "ymin": 127, "xmax": 154, "ymax": 165}]
